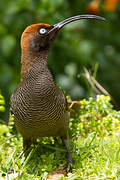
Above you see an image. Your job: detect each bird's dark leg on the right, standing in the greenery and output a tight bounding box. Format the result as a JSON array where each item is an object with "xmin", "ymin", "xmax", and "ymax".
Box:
[{"xmin": 61, "ymin": 137, "xmax": 73, "ymax": 171}]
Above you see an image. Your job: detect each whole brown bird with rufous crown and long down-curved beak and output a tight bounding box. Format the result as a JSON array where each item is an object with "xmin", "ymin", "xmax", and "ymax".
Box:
[{"xmin": 10, "ymin": 14, "xmax": 105, "ymax": 170}]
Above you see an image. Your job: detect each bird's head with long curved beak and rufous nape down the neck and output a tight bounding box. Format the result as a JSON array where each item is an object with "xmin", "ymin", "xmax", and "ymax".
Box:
[{"xmin": 21, "ymin": 14, "xmax": 105, "ymax": 82}]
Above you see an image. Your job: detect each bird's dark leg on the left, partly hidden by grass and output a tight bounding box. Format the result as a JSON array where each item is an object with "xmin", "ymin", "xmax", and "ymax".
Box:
[{"xmin": 8, "ymin": 139, "xmax": 31, "ymax": 174}]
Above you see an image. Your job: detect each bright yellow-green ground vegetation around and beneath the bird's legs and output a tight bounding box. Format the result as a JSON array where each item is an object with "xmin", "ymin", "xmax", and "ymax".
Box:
[{"xmin": 0, "ymin": 95, "xmax": 120, "ymax": 180}]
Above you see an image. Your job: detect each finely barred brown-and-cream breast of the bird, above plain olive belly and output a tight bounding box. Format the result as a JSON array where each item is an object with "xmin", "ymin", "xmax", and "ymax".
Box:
[{"xmin": 11, "ymin": 58, "xmax": 66, "ymax": 121}]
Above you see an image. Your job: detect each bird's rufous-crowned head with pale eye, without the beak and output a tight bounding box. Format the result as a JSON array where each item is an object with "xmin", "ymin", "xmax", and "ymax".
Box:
[{"xmin": 21, "ymin": 23, "xmax": 56, "ymax": 53}]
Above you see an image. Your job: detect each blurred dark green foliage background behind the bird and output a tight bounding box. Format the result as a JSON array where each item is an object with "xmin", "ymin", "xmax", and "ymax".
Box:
[{"xmin": 0, "ymin": 0, "xmax": 120, "ymax": 120}]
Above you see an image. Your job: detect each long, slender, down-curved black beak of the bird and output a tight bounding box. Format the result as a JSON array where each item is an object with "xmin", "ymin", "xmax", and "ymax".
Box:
[{"xmin": 49, "ymin": 14, "xmax": 105, "ymax": 32}]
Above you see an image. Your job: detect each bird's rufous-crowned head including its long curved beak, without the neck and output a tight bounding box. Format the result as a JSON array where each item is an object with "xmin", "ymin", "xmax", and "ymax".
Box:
[{"xmin": 21, "ymin": 14, "xmax": 105, "ymax": 53}]
